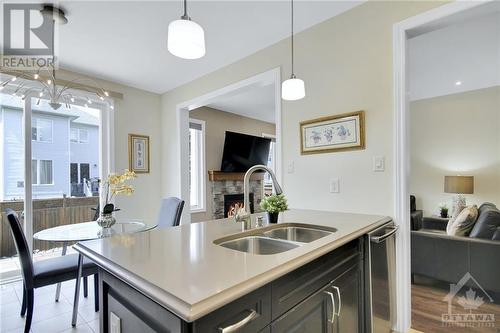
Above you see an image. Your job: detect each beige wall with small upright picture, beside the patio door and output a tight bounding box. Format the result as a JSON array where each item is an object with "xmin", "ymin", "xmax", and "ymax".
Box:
[{"xmin": 58, "ymin": 71, "xmax": 162, "ymax": 224}]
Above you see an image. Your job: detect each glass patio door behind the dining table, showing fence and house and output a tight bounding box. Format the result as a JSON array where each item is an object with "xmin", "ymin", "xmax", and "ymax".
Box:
[{"xmin": 0, "ymin": 74, "xmax": 112, "ymax": 282}]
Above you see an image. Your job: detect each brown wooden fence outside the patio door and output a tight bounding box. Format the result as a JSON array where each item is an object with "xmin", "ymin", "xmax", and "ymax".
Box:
[{"xmin": 0, "ymin": 197, "xmax": 99, "ymax": 258}]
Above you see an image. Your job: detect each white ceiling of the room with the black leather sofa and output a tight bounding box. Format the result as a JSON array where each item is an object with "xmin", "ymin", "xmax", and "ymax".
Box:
[{"xmin": 409, "ymin": 7, "xmax": 500, "ymax": 100}]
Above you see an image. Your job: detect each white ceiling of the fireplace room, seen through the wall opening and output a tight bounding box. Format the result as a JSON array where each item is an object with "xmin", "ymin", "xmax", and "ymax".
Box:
[{"xmin": 207, "ymin": 84, "xmax": 276, "ymax": 124}]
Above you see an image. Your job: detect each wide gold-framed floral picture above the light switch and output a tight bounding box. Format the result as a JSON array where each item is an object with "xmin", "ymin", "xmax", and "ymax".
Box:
[{"xmin": 300, "ymin": 111, "xmax": 365, "ymax": 155}]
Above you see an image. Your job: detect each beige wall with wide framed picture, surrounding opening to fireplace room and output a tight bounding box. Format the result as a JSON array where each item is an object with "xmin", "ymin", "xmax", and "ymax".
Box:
[{"xmin": 162, "ymin": 1, "xmax": 443, "ymax": 215}]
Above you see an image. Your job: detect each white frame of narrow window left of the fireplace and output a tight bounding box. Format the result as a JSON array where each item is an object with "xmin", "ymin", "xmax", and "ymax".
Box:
[{"xmin": 188, "ymin": 118, "xmax": 207, "ymax": 213}]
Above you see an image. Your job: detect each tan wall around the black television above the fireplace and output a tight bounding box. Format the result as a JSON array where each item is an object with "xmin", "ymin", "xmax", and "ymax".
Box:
[{"xmin": 189, "ymin": 107, "xmax": 276, "ymax": 222}]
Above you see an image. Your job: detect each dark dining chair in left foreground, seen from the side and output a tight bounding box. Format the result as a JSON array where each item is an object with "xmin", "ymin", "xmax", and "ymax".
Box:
[{"xmin": 5, "ymin": 209, "xmax": 99, "ymax": 333}]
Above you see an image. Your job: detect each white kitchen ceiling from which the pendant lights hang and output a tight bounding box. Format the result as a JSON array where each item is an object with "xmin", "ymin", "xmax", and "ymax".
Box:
[{"xmin": 0, "ymin": 0, "xmax": 364, "ymax": 93}]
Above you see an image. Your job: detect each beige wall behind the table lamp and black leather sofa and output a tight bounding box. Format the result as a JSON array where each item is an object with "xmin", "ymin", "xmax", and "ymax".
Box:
[{"xmin": 410, "ymin": 87, "xmax": 500, "ymax": 216}]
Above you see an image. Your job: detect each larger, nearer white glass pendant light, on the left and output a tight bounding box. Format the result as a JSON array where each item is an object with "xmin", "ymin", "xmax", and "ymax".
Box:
[{"xmin": 167, "ymin": 0, "xmax": 205, "ymax": 59}]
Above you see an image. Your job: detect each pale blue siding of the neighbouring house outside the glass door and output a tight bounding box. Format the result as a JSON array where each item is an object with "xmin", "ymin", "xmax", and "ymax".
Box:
[{"xmin": 0, "ymin": 107, "xmax": 99, "ymax": 200}]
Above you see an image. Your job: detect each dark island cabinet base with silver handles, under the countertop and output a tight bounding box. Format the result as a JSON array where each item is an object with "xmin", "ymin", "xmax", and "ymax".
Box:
[{"xmin": 99, "ymin": 238, "xmax": 365, "ymax": 333}]
